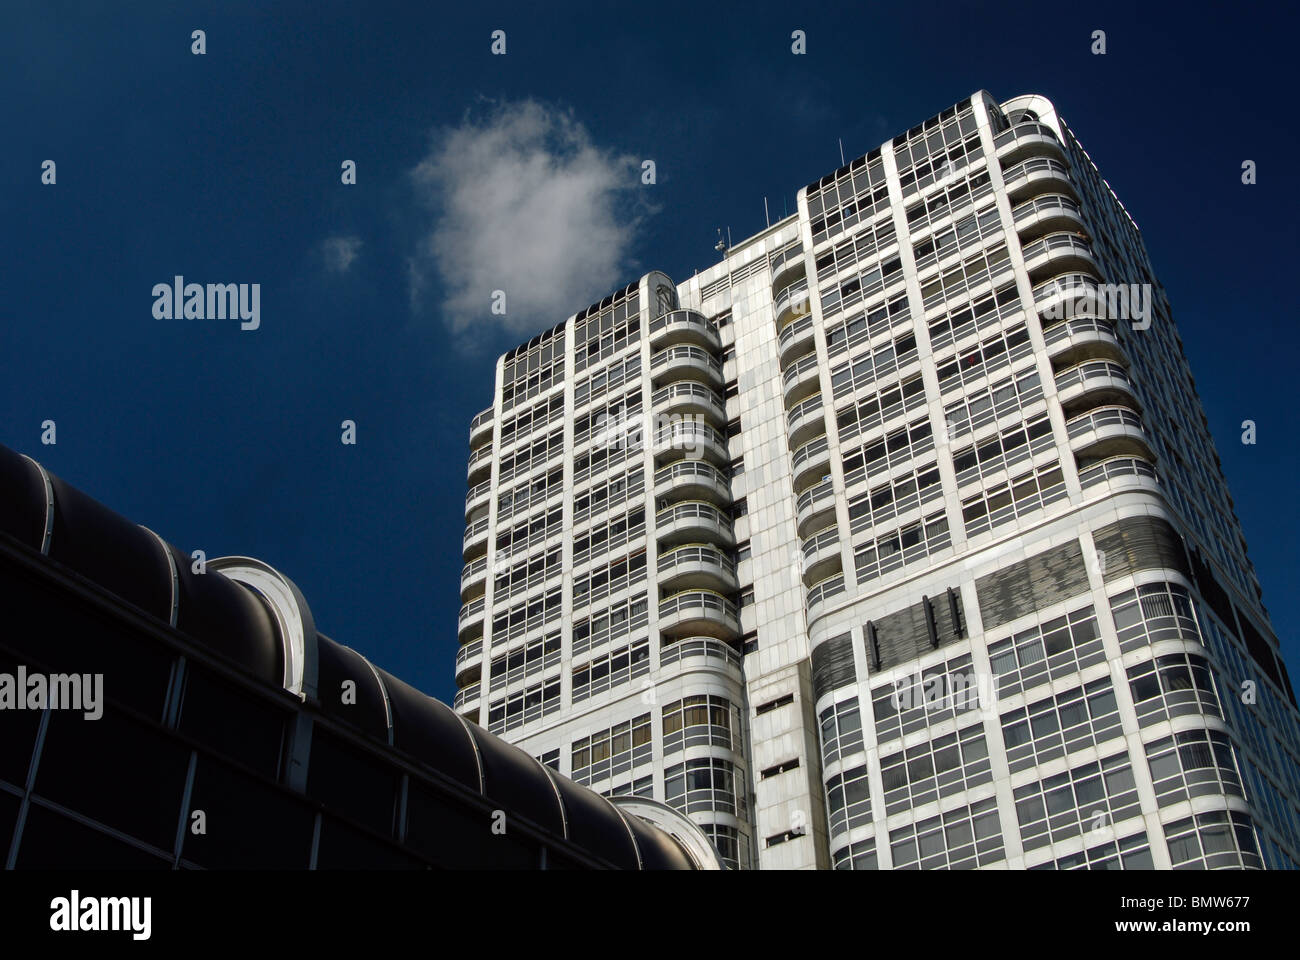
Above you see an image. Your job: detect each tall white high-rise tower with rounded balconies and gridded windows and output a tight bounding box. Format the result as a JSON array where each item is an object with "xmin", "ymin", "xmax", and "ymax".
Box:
[{"xmin": 456, "ymin": 91, "xmax": 1300, "ymax": 869}]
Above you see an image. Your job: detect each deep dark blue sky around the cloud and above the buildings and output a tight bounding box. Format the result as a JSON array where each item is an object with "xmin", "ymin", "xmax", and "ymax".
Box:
[{"xmin": 0, "ymin": 3, "xmax": 1300, "ymax": 700}]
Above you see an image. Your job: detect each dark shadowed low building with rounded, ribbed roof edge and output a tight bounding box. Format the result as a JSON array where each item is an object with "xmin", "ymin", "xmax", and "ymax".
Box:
[{"xmin": 0, "ymin": 447, "xmax": 720, "ymax": 869}]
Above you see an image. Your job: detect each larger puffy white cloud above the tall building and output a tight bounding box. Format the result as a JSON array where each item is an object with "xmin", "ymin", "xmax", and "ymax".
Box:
[{"xmin": 410, "ymin": 100, "xmax": 640, "ymax": 337}]
